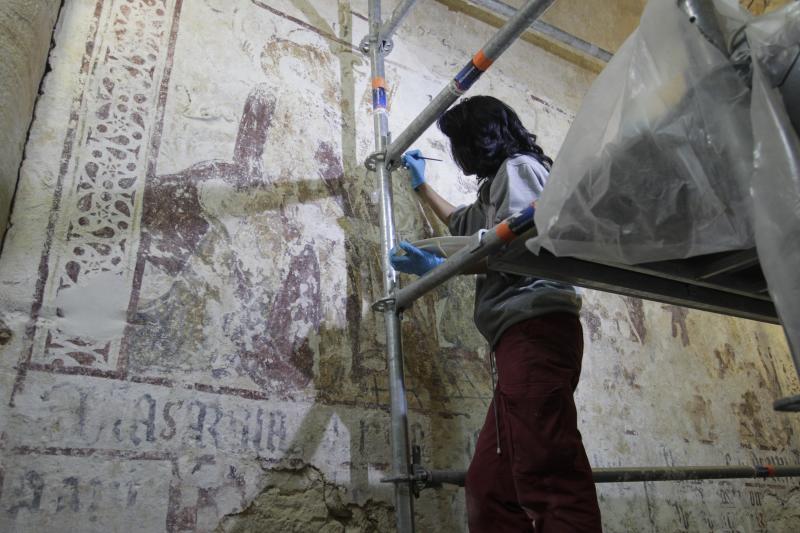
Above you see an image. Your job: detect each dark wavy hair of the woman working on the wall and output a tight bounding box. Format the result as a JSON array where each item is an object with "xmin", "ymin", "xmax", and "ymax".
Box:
[{"xmin": 437, "ymin": 96, "xmax": 553, "ymax": 181}]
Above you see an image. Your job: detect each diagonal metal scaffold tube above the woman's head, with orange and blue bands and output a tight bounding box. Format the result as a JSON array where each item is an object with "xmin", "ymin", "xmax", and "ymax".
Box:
[{"xmin": 385, "ymin": 0, "xmax": 554, "ymax": 168}]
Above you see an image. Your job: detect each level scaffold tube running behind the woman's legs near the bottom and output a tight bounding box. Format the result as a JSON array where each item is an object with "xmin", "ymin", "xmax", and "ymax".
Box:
[{"xmin": 422, "ymin": 465, "xmax": 800, "ymax": 487}]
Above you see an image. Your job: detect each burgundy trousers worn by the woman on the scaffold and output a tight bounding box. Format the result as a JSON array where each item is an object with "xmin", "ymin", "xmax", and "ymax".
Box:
[{"xmin": 465, "ymin": 313, "xmax": 602, "ymax": 533}]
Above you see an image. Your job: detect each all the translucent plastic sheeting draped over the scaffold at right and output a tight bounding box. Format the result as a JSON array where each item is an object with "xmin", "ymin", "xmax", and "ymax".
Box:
[{"xmin": 528, "ymin": 0, "xmax": 800, "ymax": 354}]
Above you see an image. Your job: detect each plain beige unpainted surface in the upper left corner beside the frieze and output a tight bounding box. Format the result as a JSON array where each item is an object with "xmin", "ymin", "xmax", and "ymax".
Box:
[{"xmin": 0, "ymin": 0, "xmax": 61, "ymax": 241}]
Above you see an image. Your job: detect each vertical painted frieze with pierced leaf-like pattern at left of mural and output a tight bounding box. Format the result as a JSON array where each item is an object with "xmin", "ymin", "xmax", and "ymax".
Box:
[{"xmin": 30, "ymin": 0, "xmax": 176, "ymax": 372}]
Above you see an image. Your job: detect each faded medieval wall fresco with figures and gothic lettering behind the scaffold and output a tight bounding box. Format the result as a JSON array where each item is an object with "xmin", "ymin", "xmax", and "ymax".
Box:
[{"xmin": 0, "ymin": 0, "xmax": 800, "ymax": 532}]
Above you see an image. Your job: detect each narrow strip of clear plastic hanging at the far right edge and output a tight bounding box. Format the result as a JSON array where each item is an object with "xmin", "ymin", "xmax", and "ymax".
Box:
[{"xmin": 747, "ymin": 2, "xmax": 800, "ymax": 369}]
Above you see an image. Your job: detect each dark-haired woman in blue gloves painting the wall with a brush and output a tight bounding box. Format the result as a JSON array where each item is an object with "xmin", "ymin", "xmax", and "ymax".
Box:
[{"xmin": 392, "ymin": 96, "xmax": 601, "ymax": 533}]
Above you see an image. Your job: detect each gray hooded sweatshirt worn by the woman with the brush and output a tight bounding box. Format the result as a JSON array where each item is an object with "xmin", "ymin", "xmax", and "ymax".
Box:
[{"xmin": 448, "ymin": 155, "xmax": 581, "ymax": 348}]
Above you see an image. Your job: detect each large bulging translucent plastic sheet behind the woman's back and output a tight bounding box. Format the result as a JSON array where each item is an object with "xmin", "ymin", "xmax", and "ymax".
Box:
[{"xmin": 529, "ymin": 1, "xmax": 754, "ymax": 264}]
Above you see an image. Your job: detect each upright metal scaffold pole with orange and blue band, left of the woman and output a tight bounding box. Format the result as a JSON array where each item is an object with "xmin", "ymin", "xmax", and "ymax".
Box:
[{"xmin": 369, "ymin": 0, "xmax": 414, "ymax": 533}]
